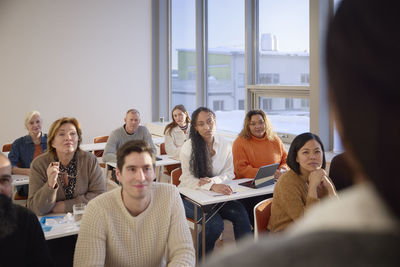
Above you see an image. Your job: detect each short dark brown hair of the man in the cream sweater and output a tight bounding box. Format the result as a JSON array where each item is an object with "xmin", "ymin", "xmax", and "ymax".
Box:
[{"xmin": 117, "ymin": 140, "xmax": 155, "ymax": 172}]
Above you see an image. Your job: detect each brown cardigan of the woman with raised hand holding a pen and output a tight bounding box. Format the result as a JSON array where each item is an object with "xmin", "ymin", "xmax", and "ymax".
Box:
[{"xmin": 27, "ymin": 150, "xmax": 106, "ymax": 215}]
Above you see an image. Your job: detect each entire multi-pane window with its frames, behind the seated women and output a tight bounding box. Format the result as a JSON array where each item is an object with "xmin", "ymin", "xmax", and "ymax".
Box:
[{"xmin": 153, "ymin": 0, "xmax": 333, "ymax": 148}]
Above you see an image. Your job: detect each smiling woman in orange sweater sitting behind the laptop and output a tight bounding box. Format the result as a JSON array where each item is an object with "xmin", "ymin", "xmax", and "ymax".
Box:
[{"xmin": 232, "ymin": 109, "xmax": 287, "ymax": 225}]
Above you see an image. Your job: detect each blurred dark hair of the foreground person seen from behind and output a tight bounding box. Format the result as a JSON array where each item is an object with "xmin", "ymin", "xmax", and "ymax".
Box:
[{"xmin": 326, "ymin": 0, "xmax": 400, "ymax": 217}]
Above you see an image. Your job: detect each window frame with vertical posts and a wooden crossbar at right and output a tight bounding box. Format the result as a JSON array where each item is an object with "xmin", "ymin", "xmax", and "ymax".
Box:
[{"xmin": 152, "ymin": 0, "xmax": 333, "ymax": 150}]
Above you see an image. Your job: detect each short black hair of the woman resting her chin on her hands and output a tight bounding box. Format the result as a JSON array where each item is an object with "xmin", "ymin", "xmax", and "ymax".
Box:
[{"xmin": 286, "ymin": 133, "xmax": 326, "ymax": 174}]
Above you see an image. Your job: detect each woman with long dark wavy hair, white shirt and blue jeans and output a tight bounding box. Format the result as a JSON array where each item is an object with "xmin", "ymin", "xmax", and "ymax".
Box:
[{"xmin": 179, "ymin": 107, "xmax": 251, "ymax": 253}]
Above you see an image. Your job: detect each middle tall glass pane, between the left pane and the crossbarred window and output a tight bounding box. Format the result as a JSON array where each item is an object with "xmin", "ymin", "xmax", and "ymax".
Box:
[{"xmin": 206, "ymin": 0, "xmax": 245, "ymax": 132}]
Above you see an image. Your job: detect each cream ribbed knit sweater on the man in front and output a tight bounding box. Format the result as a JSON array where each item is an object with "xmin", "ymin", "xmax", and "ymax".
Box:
[{"xmin": 74, "ymin": 183, "xmax": 195, "ymax": 267}]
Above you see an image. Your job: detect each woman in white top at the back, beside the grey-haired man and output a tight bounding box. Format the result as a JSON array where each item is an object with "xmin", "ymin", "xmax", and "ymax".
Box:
[{"xmin": 164, "ymin": 105, "xmax": 190, "ymax": 157}]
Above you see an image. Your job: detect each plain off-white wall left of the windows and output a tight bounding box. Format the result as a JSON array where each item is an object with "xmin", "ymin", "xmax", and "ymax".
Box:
[{"xmin": 0, "ymin": 0, "xmax": 151, "ymax": 145}]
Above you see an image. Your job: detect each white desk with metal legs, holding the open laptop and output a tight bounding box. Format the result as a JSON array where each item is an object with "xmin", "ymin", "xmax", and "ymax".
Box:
[{"xmin": 178, "ymin": 179, "xmax": 275, "ymax": 261}]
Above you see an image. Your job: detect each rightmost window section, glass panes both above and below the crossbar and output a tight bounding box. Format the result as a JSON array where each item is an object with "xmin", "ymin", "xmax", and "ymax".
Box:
[{"xmin": 255, "ymin": 0, "xmax": 310, "ymax": 138}]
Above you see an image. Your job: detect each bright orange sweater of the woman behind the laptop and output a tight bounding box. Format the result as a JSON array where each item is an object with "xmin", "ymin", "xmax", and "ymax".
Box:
[{"xmin": 232, "ymin": 136, "xmax": 287, "ymax": 179}]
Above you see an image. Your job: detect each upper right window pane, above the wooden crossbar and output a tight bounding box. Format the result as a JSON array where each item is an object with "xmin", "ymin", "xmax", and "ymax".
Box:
[{"xmin": 257, "ymin": 0, "xmax": 310, "ymax": 85}]
